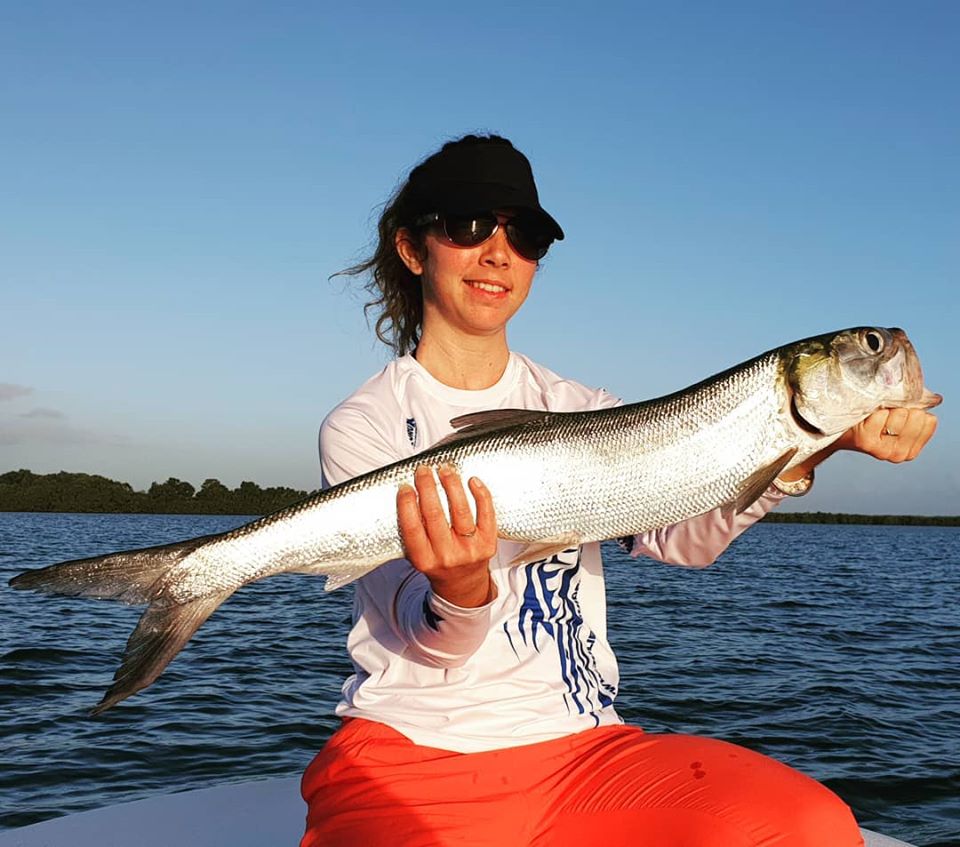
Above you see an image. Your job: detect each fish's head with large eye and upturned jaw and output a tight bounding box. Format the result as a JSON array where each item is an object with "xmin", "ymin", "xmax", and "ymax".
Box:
[{"xmin": 784, "ymin": 327, "xmax": 943, "ymax": 435}]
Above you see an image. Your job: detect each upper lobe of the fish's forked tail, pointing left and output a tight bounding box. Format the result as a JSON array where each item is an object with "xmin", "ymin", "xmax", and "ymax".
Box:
[{"xmin": 10, "ymin": 535, "xmax": 216, "ymax": 603}]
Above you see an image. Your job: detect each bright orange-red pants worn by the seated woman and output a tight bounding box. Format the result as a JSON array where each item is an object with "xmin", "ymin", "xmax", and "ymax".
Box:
[{"xmin": 300, "ymin": 719, "xmax": 863, "ymax": 847}]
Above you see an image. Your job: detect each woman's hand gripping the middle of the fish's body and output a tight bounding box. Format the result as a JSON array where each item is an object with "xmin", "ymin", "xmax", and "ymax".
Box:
[{"xmin": 397, "ymin": 465, "xmax": 497, "ymax": 608}]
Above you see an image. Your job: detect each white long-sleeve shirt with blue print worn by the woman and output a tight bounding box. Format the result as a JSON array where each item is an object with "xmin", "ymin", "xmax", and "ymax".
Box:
[{"xmin": 320, "ymin": 353, "xmax": 782, "ymax": 752}]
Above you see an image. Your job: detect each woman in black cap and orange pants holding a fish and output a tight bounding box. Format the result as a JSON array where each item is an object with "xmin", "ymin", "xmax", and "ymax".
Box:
[{"xmin": 302, "ymin": 135, "xmax": 935, "ymax": 847}]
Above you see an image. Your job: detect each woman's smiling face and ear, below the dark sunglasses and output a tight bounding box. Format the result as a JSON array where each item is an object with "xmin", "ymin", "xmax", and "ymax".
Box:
[{"xmin": 397, "ymin": 213, "xmax": 537, "ymax": 344}]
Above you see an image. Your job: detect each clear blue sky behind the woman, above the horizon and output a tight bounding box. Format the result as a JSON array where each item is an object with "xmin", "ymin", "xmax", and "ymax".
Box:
[{"xmin": 0, "ymin": 1, "xmax": 960, "ymax": 514}]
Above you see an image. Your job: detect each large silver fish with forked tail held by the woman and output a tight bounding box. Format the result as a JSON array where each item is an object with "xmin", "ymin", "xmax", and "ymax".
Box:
[{"xmin": 10, "ymin": 327, "xmax": 941, "ymax": 713}]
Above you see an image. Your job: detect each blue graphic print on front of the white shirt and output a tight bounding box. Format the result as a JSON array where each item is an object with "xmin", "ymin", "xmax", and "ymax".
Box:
[{"xmin": 503, "ymin": 548, "xmax": 616, "ymax": 724}]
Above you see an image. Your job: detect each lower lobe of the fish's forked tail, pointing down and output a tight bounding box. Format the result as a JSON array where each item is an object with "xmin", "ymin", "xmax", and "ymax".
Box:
[{"xmin": 90, "ymin": 589, "xmax": 233, "ymax": 715}]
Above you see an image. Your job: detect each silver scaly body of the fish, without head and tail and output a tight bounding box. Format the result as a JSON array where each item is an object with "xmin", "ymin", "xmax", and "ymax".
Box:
[{"xmin": 166, "ymin": 351, "xmax": 797, "ymax": 602}]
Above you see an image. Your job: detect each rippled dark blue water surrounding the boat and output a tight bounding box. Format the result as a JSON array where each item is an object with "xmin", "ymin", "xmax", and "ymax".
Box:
[{"xmin": 0, "ymin": 514, "xmax": 960, "ymax": 847}]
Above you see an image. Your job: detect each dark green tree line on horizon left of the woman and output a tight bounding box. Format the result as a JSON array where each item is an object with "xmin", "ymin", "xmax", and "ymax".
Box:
[{"xmin": 0, "ymin": 470, "xmax": 308, "ymax": 515}]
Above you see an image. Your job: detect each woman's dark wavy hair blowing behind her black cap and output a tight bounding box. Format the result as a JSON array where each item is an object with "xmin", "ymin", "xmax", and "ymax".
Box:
[{"xmin": 334, "ymin": 134, "xmax": 513, "ymax": 356}]
